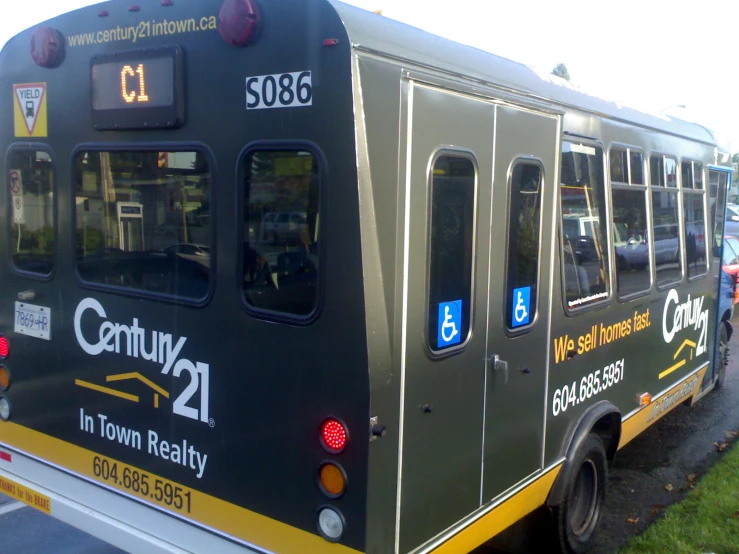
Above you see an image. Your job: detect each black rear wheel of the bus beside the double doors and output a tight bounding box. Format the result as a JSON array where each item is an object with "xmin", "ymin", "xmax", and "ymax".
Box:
[{"xmin": 554, "ymin": 433, "xmax": 608, "ymax": 554}]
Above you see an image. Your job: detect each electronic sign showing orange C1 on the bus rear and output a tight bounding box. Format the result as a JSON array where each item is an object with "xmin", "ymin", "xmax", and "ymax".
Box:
[{"xmin": 90, "ymin": 46, "xmax": 184, "ymax": 130}]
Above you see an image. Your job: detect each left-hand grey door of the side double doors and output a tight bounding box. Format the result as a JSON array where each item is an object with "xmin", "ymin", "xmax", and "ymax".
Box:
[{"xmin": 399, "ymin": 82, "xmax": 495, "ymax": 552}]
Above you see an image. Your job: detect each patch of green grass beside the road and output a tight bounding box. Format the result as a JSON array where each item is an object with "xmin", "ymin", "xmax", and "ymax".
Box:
[{"xmin": 620, "ymin": 441, "xmax": 739, "ymax": 554}]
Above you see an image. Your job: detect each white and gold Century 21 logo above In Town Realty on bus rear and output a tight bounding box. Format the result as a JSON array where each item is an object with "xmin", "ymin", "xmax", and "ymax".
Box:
[{"xmin": 74, "ymin": 298, "xmax": 214, "ymax": 426}]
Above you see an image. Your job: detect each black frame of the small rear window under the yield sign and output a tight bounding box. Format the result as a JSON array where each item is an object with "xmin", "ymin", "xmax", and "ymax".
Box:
[{"xmin": 5, "ymin": 142, "xmax": 59, "ymax": 282}]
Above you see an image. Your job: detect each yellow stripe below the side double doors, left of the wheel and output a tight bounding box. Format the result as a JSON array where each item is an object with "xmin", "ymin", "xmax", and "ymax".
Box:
[{"xmin": 431, "ymin": 464, "xmax": 562, "ymax": 554}]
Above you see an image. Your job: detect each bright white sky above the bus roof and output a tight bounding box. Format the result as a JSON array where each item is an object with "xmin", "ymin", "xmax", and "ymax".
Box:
[{"xmin": 0, "ymin": 0, "xmax": 739, "ymax": 152}]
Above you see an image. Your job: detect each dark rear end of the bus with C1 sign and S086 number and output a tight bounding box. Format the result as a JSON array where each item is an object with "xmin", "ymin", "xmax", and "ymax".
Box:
[{"xmin": 0, "ymin": 0, "xmax": 369, "ymax": 553}]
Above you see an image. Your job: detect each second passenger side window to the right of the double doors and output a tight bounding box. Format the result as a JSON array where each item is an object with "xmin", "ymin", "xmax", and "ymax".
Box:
[{"xmin": 610, "ymin": 148, "xmax": 652, "ymax": 298}]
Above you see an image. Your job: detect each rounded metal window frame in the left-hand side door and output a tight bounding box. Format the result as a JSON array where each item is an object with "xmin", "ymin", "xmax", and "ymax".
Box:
[{"xmin": 423, "ymin": 145, "xmax": 480, "ymax": 354}]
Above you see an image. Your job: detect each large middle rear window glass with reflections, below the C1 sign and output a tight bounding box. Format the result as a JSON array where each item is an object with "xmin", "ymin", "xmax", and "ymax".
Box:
[{"xmin": 74, "ymin": 151, "xmax": 211, "ymax": 299}]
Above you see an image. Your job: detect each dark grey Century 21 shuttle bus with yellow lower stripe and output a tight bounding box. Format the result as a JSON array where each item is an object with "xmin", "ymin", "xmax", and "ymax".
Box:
[{"xmin": 0, "ymin": 0, "xmax": 732, "ymax": 554}]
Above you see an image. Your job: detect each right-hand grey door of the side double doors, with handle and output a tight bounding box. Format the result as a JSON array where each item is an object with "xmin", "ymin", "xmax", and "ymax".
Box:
[{"xmin": 481, "ymin": 106, "xmax": 559, "ymax": 502}]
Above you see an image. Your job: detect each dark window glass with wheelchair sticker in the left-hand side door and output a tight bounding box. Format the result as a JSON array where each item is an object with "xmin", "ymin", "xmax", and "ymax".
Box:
[{"xmin": 427, "ymin": 154, "xmax": 477, "ymax": 352}]
